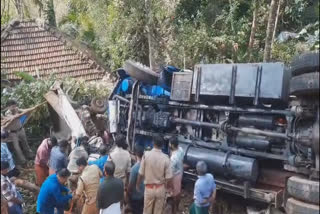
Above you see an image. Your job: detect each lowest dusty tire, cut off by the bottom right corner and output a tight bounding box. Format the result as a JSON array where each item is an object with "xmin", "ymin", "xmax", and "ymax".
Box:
[{"xmin": 285, "ymin": 198, "xmax": 320, "ymax": 214}]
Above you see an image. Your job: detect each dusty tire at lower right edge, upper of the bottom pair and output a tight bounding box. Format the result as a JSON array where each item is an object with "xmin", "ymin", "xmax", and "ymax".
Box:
[{"xmin": 287, "ymin": 176, "xmax": 319, "ymax": 204}]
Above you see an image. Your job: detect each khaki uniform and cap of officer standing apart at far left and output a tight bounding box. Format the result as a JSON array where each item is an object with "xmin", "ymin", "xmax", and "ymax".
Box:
[{"xmin": 5, "ymin": 110, "xmax": 32, "ymax": 164}]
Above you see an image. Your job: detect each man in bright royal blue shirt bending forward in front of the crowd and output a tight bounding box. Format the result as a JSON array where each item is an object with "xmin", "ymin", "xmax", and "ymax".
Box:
[{"xmin": 37, "ymin": 168, "xmax": 72, "ymax": 214}]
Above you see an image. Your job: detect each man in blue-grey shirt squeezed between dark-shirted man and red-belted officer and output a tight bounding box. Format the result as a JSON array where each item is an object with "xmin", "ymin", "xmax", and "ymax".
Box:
[{"xmin": 126, "ymin": 145, "xmax": 144, "ymax": 214}]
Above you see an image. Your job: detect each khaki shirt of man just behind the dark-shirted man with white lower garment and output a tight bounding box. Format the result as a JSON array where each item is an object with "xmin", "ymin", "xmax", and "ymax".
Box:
[{"xmin": 108, "ymin": 147, "xmax": 131, "ymax": 185}]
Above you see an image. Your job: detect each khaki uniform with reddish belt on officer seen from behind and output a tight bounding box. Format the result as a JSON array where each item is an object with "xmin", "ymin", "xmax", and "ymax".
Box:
[{"xmin": 139, "ymin": 148, "xmax": 172, "ymax": 214}]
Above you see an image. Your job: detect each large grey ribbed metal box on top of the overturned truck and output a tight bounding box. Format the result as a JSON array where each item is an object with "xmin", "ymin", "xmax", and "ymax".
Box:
[{"xmin": 192, "ymin": 63, "xmax": 290, "ymax": 105}]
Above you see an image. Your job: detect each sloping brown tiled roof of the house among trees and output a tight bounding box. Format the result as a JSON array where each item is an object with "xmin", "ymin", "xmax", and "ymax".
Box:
[{"xmin": 1, "ymin": 20, "xmax": 107, "ymax": 81}]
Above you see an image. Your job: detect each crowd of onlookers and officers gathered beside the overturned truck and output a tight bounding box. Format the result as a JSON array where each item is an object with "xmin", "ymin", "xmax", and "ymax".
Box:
[{"xmin": 1, "ymin": 99, "xmax": 216, "ymax": 214}]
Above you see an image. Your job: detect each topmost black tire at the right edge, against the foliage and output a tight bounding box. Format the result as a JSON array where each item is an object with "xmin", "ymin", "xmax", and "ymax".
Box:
[{"xmin": 291, "ymin": 51, "xmax": 319, "ymax": 76}]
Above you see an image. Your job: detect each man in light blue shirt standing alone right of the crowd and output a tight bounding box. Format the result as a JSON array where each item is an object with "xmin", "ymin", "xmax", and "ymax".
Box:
[{"xmin": 189, "ymin": 161, "xmax": 216, "ymax": 214}]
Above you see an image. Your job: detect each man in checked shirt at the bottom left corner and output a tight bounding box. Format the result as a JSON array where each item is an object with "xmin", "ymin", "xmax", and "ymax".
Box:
[{"xmin": 1, "ymin": 161, "xmax": 23, "ymax": 214}]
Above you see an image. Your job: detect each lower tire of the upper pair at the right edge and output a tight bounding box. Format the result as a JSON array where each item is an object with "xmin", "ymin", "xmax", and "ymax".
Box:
[{"xmin": 290, "ymin": 72, "xmax": 319, "ymax": 95}]
